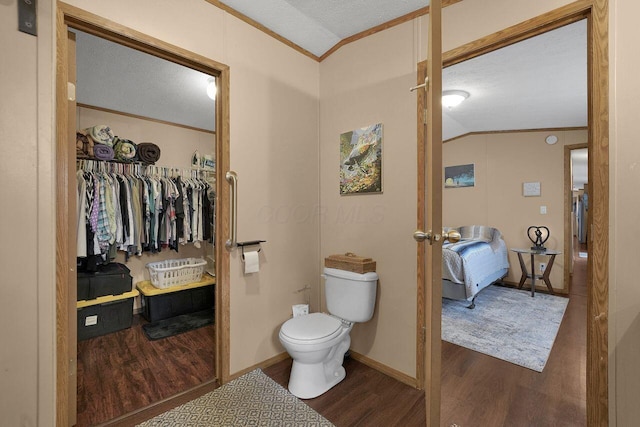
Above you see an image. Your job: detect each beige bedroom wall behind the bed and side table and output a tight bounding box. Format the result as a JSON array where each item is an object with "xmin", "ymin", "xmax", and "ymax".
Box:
[{"xmin": 442, "ymin": 130, "xmax": 587, "ymax": 289}]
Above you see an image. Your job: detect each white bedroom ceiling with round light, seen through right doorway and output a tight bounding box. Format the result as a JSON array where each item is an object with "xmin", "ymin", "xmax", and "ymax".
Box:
[{"xmin": 442, "ymin": 20, "xmax": 587, "ymax": 140}]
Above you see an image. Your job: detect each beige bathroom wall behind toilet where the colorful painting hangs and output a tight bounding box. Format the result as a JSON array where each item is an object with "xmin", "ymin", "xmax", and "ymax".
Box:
[{"xmin": 320, "ymin": 23, "xmax": 418, "ymax": 377}]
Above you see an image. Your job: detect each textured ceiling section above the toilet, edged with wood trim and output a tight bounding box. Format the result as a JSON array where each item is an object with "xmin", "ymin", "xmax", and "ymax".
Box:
[{"xmin": 221, "ymin": 0, "xmax": 429, "ymax": 57}]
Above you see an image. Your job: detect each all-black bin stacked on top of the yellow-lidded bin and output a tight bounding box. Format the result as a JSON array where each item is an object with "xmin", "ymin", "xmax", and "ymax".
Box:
[{"xmin": 77, "ymin": 262, "xmax": 133, "ymax": 301}]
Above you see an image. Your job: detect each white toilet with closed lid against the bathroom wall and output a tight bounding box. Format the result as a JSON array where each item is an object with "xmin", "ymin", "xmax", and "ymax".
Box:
[{"xmin": 279, "ymin": 268, "xmax": 378, "ymax": 399}]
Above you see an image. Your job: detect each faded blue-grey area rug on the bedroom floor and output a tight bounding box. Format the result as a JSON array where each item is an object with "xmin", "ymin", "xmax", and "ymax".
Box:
[{"xmin": 442, "ymin": 285, "xmax": 569, "ymax": 372}]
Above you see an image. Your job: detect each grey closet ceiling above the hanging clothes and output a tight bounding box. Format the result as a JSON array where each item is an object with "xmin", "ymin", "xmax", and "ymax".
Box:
[{"xmin": 75, "ymin": 31, "xmax": 215, "ymax": 130}]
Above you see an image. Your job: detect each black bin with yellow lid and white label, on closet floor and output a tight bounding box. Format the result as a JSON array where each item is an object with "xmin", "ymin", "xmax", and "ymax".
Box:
[{"xmin": 78, "ymin": 290, "xmax": 139, "ymax": 341}]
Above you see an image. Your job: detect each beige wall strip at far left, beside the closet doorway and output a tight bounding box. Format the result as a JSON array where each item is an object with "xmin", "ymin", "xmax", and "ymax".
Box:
[{"xmin": 0, "ymin": 2, "xmax": 55, "ymax": 426}]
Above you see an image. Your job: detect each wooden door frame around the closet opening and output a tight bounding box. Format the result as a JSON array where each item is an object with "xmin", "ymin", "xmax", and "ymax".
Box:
[{"xmin": 56, "ymin": 3, "xmax": 229, "ymax": 426}]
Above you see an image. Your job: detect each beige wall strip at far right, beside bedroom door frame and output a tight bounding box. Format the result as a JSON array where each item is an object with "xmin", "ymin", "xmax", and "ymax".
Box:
[{"xmin": 609, "ymin": 0, "xmax": 640, "ymax": 426}]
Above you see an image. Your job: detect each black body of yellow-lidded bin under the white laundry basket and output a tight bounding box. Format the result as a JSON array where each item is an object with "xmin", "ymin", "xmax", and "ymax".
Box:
[{"xmin": 140, "ymin": 285, "xmax": 215, "ymax": 322}]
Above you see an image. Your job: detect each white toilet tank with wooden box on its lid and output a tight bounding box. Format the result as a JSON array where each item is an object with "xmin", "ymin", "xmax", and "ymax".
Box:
[{"xmin": 324, "ymin": 268, "xmax": 378, "ymax": 322}]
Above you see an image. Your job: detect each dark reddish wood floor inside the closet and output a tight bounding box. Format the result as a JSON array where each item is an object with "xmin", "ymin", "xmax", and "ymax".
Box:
[{"xmin": 76, "ymin": 315, "xmax": 215, "ymax": 427}]
